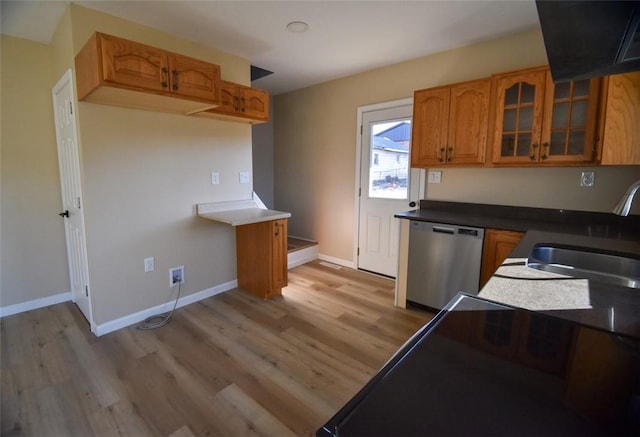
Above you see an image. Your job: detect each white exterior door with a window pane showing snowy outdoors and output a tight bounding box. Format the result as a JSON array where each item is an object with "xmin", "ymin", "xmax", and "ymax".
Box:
[{"xmin": 357, "ymin": 101, "xmax": 422, "ymax": 277}]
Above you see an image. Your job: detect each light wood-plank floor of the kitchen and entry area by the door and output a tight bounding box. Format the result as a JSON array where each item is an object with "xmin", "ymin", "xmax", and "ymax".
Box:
[{"xmin": 0, "ymin": 261, "xmax": 431, "ymax": 436}]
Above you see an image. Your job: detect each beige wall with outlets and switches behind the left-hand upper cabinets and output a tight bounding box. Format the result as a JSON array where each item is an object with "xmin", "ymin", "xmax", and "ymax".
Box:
[{"xmin": 66, "ymin": 6, "xmax": 251, "ymax": 325}]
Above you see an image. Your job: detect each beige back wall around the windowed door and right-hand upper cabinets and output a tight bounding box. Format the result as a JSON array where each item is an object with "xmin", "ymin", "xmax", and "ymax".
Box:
[{"xmin": 274, "ymin": 29, "xmax": 640, "ymax": 263}]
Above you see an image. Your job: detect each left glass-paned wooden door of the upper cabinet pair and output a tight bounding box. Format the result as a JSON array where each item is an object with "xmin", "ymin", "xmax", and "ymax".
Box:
[{"xmin": 492, "ymin": 68, "xmax": 547, "ymax": 164}]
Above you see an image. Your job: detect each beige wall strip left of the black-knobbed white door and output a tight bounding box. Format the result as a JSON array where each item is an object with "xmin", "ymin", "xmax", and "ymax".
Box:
[{"xmin": 0, "ymin": 35, "xmax": 69, "ymax": 307}]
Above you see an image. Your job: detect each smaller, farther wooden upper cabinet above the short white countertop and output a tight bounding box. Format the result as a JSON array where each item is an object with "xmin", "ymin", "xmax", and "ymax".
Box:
[{"xmin": 200, "ymin": 81, "xmax": 269, "ymax": 123}]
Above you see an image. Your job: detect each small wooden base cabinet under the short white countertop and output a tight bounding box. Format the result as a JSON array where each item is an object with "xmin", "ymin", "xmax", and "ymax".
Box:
[{"xmin": 236, "ymin": 219, "xmax": 287, "ymax": 299}]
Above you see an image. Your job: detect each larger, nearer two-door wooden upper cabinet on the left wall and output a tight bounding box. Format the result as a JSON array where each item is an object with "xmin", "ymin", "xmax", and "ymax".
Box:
[{"xmin": 75, "ymin": 32, "xmax": 221, "ymax": 114}]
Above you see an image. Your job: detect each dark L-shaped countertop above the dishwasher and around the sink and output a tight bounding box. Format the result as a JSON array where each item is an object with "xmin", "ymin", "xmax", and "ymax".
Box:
[{"xmin": 396, "ymin": 201, "xmax": 640, "ymax": 338}]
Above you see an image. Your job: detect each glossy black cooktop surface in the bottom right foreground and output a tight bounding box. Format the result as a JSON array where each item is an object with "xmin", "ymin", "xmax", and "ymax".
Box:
[{"xmin": 316, "ymin": 295, "xmax": 639, "ymax": 437}]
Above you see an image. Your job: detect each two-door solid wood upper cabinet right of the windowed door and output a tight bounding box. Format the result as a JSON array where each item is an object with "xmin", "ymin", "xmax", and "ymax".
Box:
[{"xmin": 411, "ymin": 79, "xmax": 491, "ymax": 167}]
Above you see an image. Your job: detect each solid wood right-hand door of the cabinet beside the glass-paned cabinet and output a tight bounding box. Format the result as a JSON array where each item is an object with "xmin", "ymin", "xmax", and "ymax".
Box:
[{"xmin": 446, "ymin": 79, "xmax": 491, "ymax": 165}]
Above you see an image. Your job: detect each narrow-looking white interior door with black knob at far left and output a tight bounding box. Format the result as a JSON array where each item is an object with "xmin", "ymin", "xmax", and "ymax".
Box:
[{"xmin": 52, "ymin": 70, "xmax": 95, "ymax": 332}]
